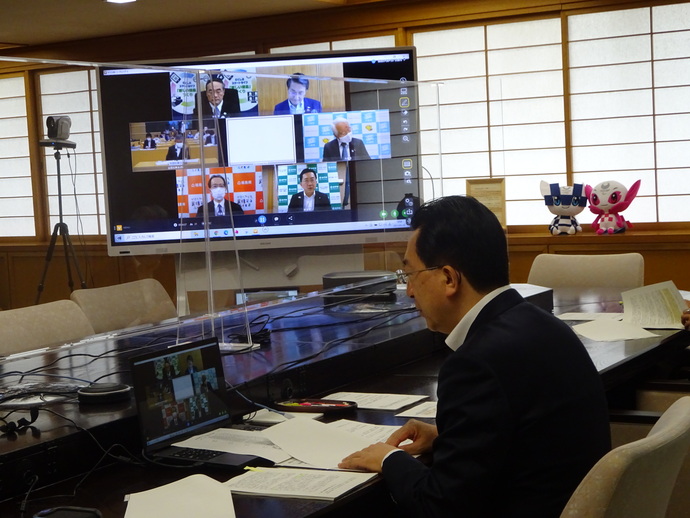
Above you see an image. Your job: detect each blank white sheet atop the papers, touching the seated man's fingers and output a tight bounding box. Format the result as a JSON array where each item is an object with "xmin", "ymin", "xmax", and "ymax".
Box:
[{"xmin": 260, "ymin": 419, "xmax": 372, "ymax": 469}]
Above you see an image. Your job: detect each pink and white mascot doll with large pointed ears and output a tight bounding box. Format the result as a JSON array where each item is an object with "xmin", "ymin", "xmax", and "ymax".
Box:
[{"xmin": 585, "ymin": 180, "xmax": 640, "ymax": 235}]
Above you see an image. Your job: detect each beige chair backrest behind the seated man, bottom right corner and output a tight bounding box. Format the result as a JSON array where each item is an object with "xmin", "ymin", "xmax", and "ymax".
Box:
[{"xmin": 561, "ymin": 397, "xmax": 690, "ymax": 518}]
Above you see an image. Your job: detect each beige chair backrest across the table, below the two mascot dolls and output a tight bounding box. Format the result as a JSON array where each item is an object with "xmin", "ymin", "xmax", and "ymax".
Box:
[{"xmin": 527, "ymin": 252, "xmax": 644, "ymax": 291}]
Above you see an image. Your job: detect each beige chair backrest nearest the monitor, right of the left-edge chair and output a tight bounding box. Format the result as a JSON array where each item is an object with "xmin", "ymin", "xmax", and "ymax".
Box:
[{"xmin": 70, "ymin": 279, "xmax": 177, "ymax": 333}]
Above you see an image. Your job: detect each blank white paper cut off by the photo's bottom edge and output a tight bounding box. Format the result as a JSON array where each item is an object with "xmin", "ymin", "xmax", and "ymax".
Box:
[{"xmin": 125, "ymin": 475, "xmax": 235, "ymax": 518}]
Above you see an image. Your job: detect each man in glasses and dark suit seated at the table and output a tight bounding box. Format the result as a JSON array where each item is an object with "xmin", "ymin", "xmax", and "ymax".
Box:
[{"xmin": 340, "ymin": 196, "xmax": 610, "ymax": 518}]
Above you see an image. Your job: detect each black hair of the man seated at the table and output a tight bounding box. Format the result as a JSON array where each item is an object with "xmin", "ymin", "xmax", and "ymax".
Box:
[{"xmin": 411, "ymin": 196, "xmax": 510, "ymax": 293}]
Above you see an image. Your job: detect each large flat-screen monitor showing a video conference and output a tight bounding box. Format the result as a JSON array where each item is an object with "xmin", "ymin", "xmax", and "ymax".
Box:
[{"xmin": 99, "ymin": 47, "xmax": 421, "ymax": 255}]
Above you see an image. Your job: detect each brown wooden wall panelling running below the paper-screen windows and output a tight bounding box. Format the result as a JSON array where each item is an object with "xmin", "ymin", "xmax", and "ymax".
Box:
[{"xmin": 0, "ymin": 235, "xmax": 690, "ymax": 309}]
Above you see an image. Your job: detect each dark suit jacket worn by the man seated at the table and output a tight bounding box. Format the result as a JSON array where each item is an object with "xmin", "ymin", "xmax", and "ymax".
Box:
[{"xmin": 383, "ymin": 290, "xmax": 610, "ymax": 518}]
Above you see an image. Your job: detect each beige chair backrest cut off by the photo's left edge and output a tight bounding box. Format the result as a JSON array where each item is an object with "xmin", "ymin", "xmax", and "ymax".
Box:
[{"xmin": 0, "ymin": 300, "xmax": 94, "ymax": 356}]
